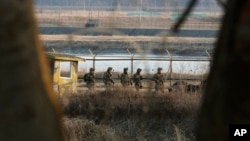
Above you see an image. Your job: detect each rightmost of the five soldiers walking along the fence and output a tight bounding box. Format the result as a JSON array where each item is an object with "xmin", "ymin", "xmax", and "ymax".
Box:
[{"xmin": 153, "ymin": 68, "xmax": 164, "ymax": 93}]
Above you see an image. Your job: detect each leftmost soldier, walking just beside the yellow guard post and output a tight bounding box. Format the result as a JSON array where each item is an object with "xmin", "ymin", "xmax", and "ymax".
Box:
[{"xmin": 84, "ymin": 68, "xmax": 95, "ymax": 90}]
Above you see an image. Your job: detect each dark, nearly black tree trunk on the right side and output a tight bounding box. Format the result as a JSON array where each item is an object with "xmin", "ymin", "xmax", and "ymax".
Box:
[{"xmin": 197, "ymin": 0, "xmax": 250, "ymax": 141}]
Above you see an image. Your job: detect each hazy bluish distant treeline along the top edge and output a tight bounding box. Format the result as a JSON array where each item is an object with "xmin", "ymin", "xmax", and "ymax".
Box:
[{"xmin": 35, "ymin": 0, "xmax": 218, "ymax": 8}]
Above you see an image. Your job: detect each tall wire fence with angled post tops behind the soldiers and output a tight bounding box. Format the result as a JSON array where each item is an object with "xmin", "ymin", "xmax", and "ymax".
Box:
[{"xmin": 75, "ymin": 49, "xmax": 212, "ymax": 85}]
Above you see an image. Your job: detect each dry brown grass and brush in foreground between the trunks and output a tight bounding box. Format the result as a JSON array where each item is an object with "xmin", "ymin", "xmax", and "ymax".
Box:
[{"xmin": 60, "ymin": 89, "xmax": 201, "ymax": 141}]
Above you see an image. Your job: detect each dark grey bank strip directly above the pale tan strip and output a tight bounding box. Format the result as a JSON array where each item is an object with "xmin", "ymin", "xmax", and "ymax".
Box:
[{"xmin": 39, "ymin": 27, "xmax": 218, "ymax": 37}]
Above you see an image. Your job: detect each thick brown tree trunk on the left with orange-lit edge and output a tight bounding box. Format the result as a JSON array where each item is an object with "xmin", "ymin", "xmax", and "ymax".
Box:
[{"xmin": 0, "ymin": 0, "xmax": 62, "ymax": 141}]
